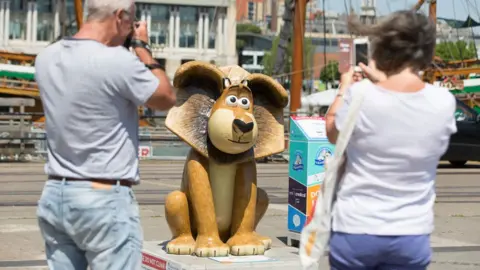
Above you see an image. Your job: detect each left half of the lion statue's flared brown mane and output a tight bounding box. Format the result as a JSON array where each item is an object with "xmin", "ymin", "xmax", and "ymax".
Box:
[{"xmin": 165, "ymin": 61, "xmax": 224, "ymax": 157}]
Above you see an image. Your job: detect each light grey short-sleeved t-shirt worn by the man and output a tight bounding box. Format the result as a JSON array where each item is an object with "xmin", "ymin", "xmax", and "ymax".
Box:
[{"xmin": 35, "ymin": 38, "xmax": 159, "ymax": 181}]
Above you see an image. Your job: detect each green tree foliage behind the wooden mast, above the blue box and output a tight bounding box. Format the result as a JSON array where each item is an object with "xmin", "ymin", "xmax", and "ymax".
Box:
[{"xmin": 262, "ymin": 36, "xmax": 315, "ymax": 80}]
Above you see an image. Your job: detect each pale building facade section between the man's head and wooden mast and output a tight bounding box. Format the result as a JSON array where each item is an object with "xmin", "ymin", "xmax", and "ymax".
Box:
[{"xmin": 136, "ymin": 0, "xmax": 238, "ymax": 78}]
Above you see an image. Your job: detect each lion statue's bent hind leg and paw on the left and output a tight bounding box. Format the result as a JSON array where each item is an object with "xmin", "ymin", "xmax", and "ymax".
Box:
[{"xmin": 165, "ymin": 191, "xmax": 195, "ymax": 255}]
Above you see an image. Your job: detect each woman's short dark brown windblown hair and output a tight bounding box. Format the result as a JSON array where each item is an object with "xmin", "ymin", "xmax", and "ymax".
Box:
[{"xmin": 348, "ymin": 10, "xmax": 436, "ymax": 75}]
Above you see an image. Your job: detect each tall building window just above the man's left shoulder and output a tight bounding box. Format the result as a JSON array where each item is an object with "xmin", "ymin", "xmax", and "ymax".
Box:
[{"xmin": 36, "ymin": 0, "xmax": 56, "ymax": 42}]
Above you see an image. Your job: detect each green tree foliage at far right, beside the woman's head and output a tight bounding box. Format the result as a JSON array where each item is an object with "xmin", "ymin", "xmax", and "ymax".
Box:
[{"xmin": 435, "ymin": 40, "xmax": 477, "ymax": 61}]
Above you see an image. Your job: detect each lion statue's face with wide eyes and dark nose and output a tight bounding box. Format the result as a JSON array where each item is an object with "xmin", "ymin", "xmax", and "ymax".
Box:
[{"xmin": 208, "ymin": 78, "xmax": 258, "ymax": 154}]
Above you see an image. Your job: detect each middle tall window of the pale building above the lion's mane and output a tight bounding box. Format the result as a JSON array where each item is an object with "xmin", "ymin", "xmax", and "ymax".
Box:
[{"xmin": 179, "ymin": 6, "xmax": 200, "ymax": 48}]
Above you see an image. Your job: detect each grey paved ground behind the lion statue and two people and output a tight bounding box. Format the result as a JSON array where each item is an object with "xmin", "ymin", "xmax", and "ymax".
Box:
[{"xmin": 0, "ymin": 161, "xmax": 480, "ymax": 270}]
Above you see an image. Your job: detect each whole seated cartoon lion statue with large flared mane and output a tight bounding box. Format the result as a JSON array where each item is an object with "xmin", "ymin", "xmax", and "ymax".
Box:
[{"xmin": 165, "ymin": 61, "xmax": 288, "ymax": 257}]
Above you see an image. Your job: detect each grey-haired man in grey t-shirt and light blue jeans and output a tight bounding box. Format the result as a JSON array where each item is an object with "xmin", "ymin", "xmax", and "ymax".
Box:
[{"xmin": 35, "ymin": 0, "xmax": 175, "ymax": 270}]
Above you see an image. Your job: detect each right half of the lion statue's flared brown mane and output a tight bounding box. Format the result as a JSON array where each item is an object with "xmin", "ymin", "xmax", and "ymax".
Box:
[{"xmin": 248, "ymin": 74, "xmax": 288, "ymax": 159}]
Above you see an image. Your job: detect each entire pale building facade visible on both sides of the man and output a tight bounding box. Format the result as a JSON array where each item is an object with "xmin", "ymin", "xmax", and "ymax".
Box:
[{"xmin": 0, "ymin": 0, "xmax": 237, "ymax": 78}]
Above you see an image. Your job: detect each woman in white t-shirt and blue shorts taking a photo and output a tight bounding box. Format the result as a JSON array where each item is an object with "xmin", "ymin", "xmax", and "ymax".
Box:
[{"xmin": 326, "ymin": 11, "xmax": 456, "ymax": 270}]
